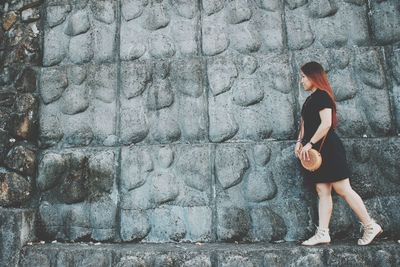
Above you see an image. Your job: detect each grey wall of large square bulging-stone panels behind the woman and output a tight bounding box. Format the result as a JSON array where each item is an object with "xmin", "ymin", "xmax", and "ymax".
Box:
[{"xmin": 3, "ymin": 0, "xmax": 400, "ymax": 258}]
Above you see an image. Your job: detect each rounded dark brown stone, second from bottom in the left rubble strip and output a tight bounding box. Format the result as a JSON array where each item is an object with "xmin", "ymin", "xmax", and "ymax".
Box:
[{"xmin": 4, "ymin": 145, "xmax": 36, "ymax": 176}]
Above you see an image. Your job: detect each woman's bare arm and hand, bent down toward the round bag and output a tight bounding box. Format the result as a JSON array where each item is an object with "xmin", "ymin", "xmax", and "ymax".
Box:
[{"xmin": 299, "ymin": 108, "xmax": 332, "ymax": 160}]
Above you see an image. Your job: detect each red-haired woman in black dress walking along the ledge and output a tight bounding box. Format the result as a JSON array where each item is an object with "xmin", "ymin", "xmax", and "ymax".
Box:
[{"xmin": 295, "ymin": 62, "xmax": 382, "ymax": 246}]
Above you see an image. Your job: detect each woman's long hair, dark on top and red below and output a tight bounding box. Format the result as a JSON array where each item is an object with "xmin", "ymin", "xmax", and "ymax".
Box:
[{"xmin": 301, "ymin": 61, "xmax": 337, "ymax": 128}]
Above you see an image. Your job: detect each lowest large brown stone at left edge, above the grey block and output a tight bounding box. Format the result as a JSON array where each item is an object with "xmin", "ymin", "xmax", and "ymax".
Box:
[{"xmin": 0, "ymin": 172, "xmax": 32, "ymax": 207}]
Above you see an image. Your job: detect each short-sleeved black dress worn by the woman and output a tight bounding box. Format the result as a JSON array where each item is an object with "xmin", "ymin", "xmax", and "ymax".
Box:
[{"xmin": 300, "ymin": 89, "xmax": 350, "ymax": 183}]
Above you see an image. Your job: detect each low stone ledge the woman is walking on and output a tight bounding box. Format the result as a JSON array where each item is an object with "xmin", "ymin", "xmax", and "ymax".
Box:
[{"xmin": 19, "ymin": 240, "xmax": 400, "ymax": 267}]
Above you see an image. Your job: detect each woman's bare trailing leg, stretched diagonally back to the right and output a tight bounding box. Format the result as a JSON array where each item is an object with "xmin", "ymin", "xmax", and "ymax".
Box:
[{"xmin": 332, "ymin": 179, "xmax": 371, "ymax": 225}]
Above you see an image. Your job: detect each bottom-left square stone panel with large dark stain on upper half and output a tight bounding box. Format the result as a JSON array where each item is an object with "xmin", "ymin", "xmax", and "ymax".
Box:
[{"xmin": 37, "ymin": 149, "xmax": 117, "ymax": 243}]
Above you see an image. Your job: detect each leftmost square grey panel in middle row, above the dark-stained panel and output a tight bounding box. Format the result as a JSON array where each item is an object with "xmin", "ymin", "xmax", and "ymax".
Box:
[{"xmin": 39, "ymin": 64, "xmax": 117, "ymax": 147}]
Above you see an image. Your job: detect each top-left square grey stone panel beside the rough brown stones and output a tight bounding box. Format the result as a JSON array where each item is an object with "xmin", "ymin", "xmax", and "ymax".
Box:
[{"xmin": 43, "ymin": 0, "xmax": 117, "ymax": 66}]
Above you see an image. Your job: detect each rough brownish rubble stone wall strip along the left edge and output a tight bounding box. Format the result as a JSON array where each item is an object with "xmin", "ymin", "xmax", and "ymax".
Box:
[{"xmin": 0, "ymin": 0, "xmax": 42, "ymax": 266}]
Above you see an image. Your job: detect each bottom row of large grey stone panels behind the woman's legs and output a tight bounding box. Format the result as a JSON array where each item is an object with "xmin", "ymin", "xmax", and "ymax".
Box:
[{"xmin": 37, "ymin": 138, "xmax": 400, "ymax": 242}]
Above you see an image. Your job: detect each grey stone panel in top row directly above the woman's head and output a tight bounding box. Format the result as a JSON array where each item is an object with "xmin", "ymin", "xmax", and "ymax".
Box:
[{"xmin": 286, "ymin": 1, "xmax": 369, "ymax": 49}]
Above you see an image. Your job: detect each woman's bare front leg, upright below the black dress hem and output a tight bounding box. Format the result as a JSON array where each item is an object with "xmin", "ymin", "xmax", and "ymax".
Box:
[{"xmin": 315, "ymin": 183, "xmax": 333, "ymax": 229}]
